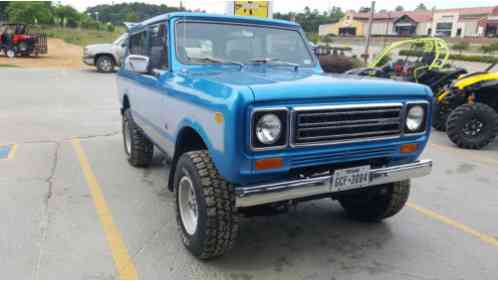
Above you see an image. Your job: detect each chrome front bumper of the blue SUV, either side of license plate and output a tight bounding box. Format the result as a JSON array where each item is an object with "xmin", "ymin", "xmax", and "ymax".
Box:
[{"xmin": 235, "ymin": 160, "xmax": 432, "ymax": 207}]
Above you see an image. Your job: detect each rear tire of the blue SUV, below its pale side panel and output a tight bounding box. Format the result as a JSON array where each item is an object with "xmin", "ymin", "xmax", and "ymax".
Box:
[{"xmin": 122, "ymin": 109, "xmax": 154, "ymax": 167}]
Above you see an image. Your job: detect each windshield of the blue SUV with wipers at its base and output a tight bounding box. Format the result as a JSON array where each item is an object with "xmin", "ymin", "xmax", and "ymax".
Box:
[{"xmin": 176, "ymin": 22, "xmax": 314, "ymax": 67}]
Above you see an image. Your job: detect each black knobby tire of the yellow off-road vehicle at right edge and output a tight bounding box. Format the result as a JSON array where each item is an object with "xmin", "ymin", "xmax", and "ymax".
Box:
[{"xmin": 446, "ymin": 103, "xmax": 498, "ymax": 149}]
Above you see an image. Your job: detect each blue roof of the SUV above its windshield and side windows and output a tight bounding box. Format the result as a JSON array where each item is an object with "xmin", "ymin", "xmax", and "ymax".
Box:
[{"xmin": 130, "ymin": 12, "xmax": 299, "ymax": 32}]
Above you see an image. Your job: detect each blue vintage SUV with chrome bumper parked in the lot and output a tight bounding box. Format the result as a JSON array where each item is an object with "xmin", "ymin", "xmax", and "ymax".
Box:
[{"xmin": 118, "ymin": 13, "xmax": 433, "ymax": 259}]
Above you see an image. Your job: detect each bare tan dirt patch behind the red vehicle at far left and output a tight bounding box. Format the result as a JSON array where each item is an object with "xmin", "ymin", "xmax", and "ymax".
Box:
[{"xmin": 0, "ymin": 38, "xmax": 88, "ymax": 69}]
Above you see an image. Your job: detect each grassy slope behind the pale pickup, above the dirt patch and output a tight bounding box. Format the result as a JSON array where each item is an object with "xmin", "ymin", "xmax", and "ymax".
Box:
[{"xmin": 32, "ymin": 27, "xmax": 125, "ymax": 46}]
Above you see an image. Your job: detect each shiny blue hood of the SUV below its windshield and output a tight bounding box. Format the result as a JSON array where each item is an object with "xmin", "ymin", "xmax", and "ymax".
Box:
[{"xmin": 187, "ymin": 67, "xmax": 432, "ymax": 102}]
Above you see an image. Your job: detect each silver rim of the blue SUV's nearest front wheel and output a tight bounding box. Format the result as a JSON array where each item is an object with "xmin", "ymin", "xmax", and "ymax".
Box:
[{"xmin": 178, "ymin": 175, "xmax": 198, "ymax": 235}]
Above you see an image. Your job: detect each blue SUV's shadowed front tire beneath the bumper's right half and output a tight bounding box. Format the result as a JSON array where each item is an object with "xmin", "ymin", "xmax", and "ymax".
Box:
[{"xmin": 338, "ymin": 180, "xmax": 410, "ymax": 222}]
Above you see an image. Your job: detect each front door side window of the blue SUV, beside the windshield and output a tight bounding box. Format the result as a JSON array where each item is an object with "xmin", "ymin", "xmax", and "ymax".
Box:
[{"xmin": 148, "ymin": 23, "xmax": 168, "ymax": 69}]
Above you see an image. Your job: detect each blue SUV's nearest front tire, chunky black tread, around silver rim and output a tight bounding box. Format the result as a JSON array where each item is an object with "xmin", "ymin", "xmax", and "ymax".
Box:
[{"xmin": 174, "ymin": 150, "xmax": 239, "ymax": 260}]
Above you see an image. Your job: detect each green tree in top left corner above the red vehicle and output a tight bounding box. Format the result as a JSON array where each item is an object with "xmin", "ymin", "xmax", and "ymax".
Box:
[{"xmin": 6, "ymin": 1, "xmax": 53, "ymax": 24}]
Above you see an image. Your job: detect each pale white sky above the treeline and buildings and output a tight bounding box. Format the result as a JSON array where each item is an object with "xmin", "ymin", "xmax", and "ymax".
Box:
[{"xmin": 59, "ymin": 0, "xmax": 498, "ymax": 13}]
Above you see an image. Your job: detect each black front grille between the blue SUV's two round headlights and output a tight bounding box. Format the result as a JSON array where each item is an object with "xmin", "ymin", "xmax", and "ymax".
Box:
[{"xmin": 293, "ymin": 104, "xmax": 403, "ymax": 146}]
